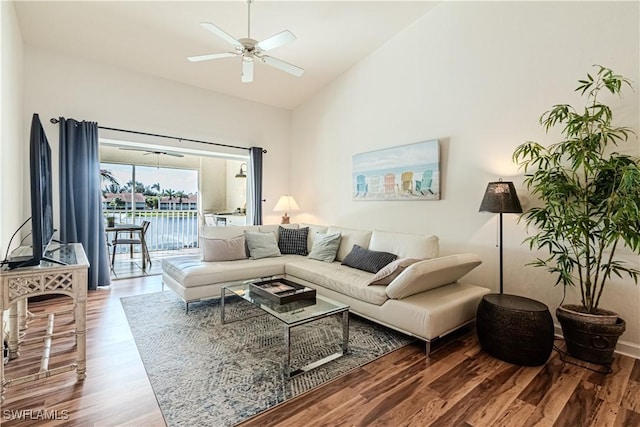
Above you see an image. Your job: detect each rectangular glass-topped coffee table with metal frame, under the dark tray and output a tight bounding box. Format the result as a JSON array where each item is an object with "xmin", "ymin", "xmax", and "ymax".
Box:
[{"xmin": 220, "ymin": 279, "xmax": 349, "ymax": 378}]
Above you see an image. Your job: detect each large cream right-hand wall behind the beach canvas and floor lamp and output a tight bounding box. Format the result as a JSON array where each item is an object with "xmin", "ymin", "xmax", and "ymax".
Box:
[{"xmin": 290, "ymin": 2, "xmax": 640, "ymax": 356}]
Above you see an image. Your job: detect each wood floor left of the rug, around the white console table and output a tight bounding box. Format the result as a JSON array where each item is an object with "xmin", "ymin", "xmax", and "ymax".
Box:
[{"xmin": 0, "ymin": 276, "xmax": 165, "ymax": 427}]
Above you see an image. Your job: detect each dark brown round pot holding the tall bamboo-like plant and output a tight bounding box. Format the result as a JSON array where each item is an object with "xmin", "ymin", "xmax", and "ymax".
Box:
[{"xmin": 556, "ymin": 306, "xmax": 626, "ymax": 366}]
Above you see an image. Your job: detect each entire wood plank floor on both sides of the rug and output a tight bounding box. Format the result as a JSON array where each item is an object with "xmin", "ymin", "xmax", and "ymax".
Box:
[{"xmin": 0, "ymin": 276, "xmax": 640, "ymax": 427}]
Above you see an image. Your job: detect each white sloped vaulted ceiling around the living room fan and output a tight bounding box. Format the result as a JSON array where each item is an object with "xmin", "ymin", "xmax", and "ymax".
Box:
[{"xmin": 16, "ymin": 0, "xmax": 437, "ymax": 109}]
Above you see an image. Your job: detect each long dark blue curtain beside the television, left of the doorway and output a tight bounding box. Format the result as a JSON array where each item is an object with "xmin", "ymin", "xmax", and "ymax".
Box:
[{"xmin": 60, "ymin": 117, "xmax": 111, "ymax": 289}]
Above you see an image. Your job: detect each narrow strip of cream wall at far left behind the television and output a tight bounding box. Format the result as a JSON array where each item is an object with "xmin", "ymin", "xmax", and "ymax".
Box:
[{"xmin": 0, "ymin": 1, "xmax": 24, "ymax": 259}]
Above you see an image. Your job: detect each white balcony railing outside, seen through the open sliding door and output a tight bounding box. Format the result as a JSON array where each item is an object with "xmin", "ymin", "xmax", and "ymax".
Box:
[{"xmin": 103, "ymin": 209, "xmax": 199, "ymax": 253}]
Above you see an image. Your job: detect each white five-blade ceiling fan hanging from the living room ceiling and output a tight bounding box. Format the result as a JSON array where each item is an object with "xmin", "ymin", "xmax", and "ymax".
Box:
[{"xmin": 187, "ymin": 0, "xmax": 304, "ymax": 83}]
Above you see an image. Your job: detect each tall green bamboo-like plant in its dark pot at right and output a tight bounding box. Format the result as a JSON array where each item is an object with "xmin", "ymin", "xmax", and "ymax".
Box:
[{"xmin": 513, "ymin": 65, "xmax": 640, "ymax": 365}]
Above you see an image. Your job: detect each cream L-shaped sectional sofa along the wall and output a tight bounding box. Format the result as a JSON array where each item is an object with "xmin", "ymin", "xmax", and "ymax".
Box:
[{"xmin": 162, "ymin": 224, "xmax": 490, "ymax": 354}]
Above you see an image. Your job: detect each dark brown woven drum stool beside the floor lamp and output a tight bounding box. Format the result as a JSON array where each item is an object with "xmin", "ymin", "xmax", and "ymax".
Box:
[{"xmin": 476, "ymin": 294, "xmax": 553, "ymax": 366}]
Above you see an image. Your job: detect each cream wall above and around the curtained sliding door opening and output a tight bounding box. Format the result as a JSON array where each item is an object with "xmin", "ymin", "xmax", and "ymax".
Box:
[{"xmin": 23, "ymin": 45, "xmax": 290, "ymax": 229}]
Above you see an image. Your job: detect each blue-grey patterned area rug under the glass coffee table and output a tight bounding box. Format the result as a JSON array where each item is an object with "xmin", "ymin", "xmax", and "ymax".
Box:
[{"xmin": 121, "ymin": 292, "xmax": 413, "ymax": 427}]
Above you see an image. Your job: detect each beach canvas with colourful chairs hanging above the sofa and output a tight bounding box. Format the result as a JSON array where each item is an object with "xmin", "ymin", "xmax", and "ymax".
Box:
[{"xmin": 352, "ymin": 139, "xmax": 440, "ymax": 200}]
